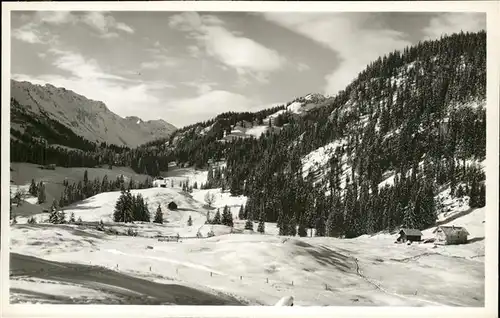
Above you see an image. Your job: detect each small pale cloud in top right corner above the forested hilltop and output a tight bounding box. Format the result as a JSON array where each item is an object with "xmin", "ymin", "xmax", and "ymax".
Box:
[{"xmin": 422, "ymin": 12, "xmax": 486, "ymax": 40}]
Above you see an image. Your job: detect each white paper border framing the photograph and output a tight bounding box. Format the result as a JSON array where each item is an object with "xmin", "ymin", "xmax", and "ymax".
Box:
[{"xmin": 0, "ymin": 1, "xmax": 500, "ymax": 318}]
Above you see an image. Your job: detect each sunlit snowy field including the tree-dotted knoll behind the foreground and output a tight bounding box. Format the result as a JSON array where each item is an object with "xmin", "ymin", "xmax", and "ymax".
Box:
[{"xmin": 10, "ymin": 169, "xmax": 485, "ymax": 306}]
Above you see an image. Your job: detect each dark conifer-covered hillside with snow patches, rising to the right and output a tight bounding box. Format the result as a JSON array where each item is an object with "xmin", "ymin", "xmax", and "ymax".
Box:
[{"xmin": 11, "ymin": 32, "xmax": 486, "ymax": 237}]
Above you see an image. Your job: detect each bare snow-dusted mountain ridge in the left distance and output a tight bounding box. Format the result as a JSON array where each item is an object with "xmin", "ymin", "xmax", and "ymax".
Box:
[{"xmin": 11, "ymin": 80, "xmax": 176, "ymax": 147}]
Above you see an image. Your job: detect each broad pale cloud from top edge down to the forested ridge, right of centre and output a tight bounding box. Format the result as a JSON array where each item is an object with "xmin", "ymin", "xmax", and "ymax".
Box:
[{"xmin": 263, "ymin": 12, "xmax": 411, "ymax": 94}]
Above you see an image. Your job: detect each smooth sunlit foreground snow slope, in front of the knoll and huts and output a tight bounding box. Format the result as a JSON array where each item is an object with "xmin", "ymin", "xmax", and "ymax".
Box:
[{"xmin": 11, "ymin": 209, "xmax": 484, "ymax": 306}]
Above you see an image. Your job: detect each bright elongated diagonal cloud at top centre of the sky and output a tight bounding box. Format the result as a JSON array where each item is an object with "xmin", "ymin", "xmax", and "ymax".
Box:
[{"xmin": 169, "ymin": 12, "xmax": 286, "ymax": 82}]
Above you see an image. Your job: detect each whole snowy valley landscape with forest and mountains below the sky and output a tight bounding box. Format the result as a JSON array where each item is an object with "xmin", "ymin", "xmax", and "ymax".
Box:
[{"xmin": 9, "ymin": 31, "xmax": 491, "ymax": 307}]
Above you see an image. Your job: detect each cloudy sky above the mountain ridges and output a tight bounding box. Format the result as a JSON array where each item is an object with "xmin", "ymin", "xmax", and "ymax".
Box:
[{"xmin": 11, "ymin": 11, "xmax": 486, "ymax": 127}]
